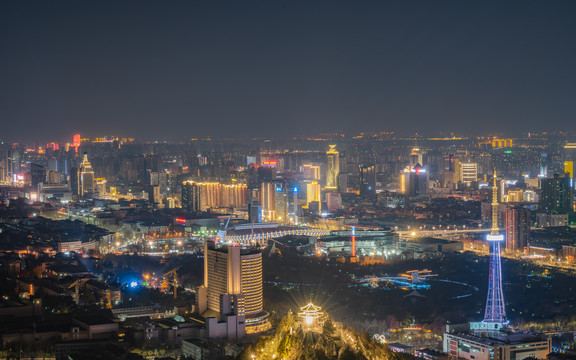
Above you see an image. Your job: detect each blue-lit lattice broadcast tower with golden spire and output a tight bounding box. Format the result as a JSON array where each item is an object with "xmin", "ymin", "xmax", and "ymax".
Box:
[{"xmin": 482, "ymin": 171, "xmax": 506, "ymax": 324}]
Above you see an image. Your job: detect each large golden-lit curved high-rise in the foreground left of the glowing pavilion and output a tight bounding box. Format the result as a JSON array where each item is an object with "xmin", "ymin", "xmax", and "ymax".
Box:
[{"xmin": 198, "ymin": 241, "xmax": 270, "ymax": 339}]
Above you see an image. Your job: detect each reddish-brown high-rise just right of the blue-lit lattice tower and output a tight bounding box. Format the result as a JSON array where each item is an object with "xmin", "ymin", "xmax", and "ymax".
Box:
[{"xmin": 506, "ymin": 205, "xmax": 530, "ymax": 252}]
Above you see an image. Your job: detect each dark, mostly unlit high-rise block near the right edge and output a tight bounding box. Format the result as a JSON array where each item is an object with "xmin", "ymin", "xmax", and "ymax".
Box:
[{"xmin": 540, "ymin": 174, "xmax": 574, "ymax": 217}]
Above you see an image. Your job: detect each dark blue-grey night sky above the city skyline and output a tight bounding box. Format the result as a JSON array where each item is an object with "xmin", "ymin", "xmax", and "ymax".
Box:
[{"xmin": 0, "ymin": 0, "xmax": 576, "ymax": 140}]
